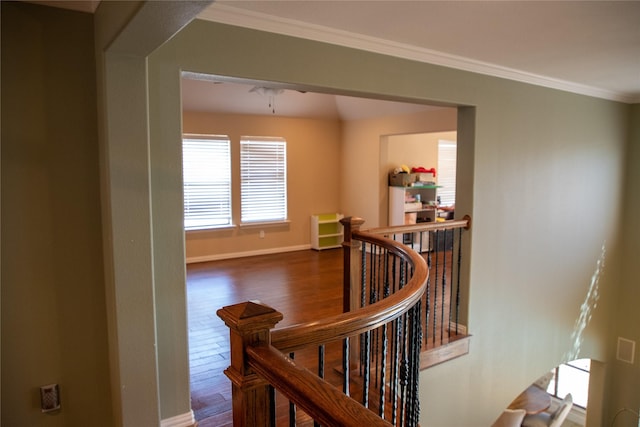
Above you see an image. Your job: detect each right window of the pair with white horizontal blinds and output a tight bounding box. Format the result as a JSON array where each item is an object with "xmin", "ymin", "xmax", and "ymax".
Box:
[{"xmin": 240, "ymin": 136, "xmax": 287, "ymax": 224}]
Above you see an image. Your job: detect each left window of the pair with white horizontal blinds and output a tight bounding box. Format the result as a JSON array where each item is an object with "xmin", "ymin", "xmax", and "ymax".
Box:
[{"xmin": 182, "ymin": 135, "xmax": 231, "ymax": 230}]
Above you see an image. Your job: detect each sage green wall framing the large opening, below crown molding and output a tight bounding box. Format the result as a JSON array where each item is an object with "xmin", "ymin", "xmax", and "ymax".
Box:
[{"xmin": 149, "ymin": 21, "xmax": 629, "ymax": 426}]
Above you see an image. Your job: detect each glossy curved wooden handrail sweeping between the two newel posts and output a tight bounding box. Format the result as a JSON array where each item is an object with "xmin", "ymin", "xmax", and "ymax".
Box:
[{"xmin": 271, "ymin": 231, "xmax": 429, "ymax": 353}]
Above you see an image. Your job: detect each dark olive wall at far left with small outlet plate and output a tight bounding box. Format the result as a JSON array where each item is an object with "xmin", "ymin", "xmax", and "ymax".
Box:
[{"xmin": 0, "ymin": 2, "xmax": 113, "ymax": 427}]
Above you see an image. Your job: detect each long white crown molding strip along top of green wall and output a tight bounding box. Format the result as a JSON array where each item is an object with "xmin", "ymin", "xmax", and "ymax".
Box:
[{"xmin": 198, "ymin": 3, "xmax": 640, "ymax": 104}]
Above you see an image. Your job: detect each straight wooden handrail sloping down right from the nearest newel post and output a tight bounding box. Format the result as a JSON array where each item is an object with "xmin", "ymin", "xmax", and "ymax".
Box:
[{"xmin": 247, "ymin": 344, "xmax": 391, "ymax": 427}]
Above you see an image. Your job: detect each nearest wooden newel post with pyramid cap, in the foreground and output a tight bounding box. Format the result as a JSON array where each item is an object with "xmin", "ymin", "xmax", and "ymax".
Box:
[{"xmin": 217, "ymin": 302, "xmax": 282, "ymax": 427}]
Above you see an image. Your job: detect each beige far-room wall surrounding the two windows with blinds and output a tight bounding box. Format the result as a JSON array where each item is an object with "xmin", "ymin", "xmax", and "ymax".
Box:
[{"xmin": 183, "ymin": 109, "xmax": 456, "ymax": 262}]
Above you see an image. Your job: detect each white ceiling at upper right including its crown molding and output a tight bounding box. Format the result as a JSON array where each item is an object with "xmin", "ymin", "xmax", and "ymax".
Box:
[{"xmin": 199, "ymin": 0, "xmax": 640, "ymax": 103}]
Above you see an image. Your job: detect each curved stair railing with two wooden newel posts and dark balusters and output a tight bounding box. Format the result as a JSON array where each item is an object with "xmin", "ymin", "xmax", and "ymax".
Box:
[{"xmin": 218, "ymin": 218, "xmax": 428, "ymax": 427}]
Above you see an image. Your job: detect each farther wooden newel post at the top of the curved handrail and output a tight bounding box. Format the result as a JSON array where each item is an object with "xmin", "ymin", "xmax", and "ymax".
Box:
[{"xmin": 340, "ymin": 216, "xmax": 364, "ymax": 313}]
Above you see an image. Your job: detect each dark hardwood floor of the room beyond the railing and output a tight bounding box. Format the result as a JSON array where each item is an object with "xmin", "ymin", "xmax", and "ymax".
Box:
[{"xmin": 187, "ymin": 249, "xmax": 342, "ymax": 427}]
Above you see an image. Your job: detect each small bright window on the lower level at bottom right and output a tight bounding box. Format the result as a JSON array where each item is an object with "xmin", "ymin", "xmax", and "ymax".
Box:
[{"xmin": 547, "ymin": 359, "xmax": 591, "ymax": 408}]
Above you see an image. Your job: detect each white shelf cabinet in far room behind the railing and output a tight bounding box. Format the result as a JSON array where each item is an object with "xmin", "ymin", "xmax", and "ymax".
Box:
[{"xmin": 389, "ymin": 185, "xmax": 438, "ymax": 250}]
